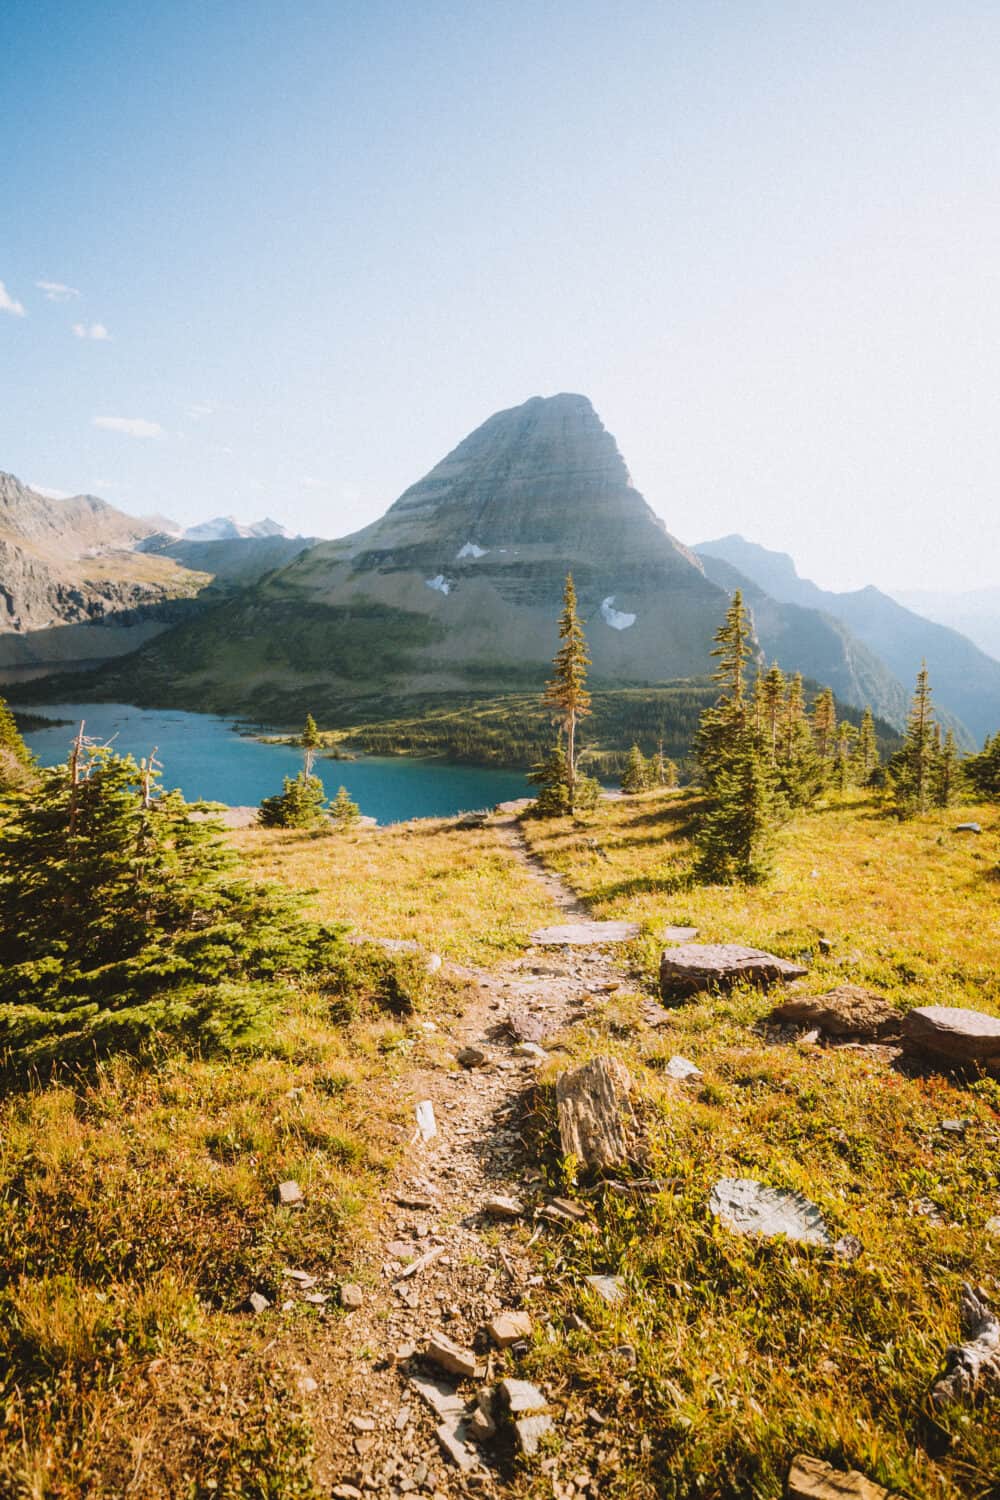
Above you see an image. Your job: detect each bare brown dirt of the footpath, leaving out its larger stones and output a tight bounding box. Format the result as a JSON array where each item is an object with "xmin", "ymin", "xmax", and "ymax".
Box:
[{"xmin": 303, "ymin": 819, "xmax": 624, "ymax": 1500}]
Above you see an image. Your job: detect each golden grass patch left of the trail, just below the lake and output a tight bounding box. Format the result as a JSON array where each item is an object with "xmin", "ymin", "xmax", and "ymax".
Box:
[{"xmin": 234, "ymin": 819, "xmax": 555, "ymax": 965}]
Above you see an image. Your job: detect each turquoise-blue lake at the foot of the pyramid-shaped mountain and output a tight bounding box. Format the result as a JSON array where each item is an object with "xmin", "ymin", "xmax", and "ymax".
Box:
[{"xmin": 15, "ymin": 704, "xmax": 529, "ymax": 824}]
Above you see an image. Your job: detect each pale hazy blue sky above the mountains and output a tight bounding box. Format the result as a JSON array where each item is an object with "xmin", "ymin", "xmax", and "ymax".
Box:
[{"xmin": 0, "ymin": 0, "xmax": 1000, "ymax": 588}]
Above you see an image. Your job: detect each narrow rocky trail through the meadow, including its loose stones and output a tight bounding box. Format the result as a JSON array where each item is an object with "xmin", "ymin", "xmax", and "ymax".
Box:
[{"xmin": 300, "ymin": 819, "xmax": 638, "ymax": 1500}]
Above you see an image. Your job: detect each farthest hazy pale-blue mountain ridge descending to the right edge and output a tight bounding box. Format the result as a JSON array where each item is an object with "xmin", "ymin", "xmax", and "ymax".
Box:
[{"xmin": 694, "ymin": 536, "xmax": 1000, "ymax": 741}]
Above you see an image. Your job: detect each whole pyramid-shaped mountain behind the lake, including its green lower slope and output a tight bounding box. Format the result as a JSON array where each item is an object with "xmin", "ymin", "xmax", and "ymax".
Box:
[{"xmin": 66, "ymin": 395, "xmax": 726, "ymax": 722}]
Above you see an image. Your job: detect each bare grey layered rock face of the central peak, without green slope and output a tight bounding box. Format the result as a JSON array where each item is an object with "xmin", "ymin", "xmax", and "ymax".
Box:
[{"xmin": 277, "ymin": 395, "xmax": 726, "ymax": 690}]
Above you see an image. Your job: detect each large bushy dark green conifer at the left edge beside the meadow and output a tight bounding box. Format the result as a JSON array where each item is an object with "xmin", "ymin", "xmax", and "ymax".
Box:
[{"xmin": 0, "ymin": 741, "xmax": 355, "ymax": 1071}]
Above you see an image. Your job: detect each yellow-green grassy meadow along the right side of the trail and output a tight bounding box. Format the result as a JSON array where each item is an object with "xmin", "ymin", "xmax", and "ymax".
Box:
[{"xmin": 509, "ymin": 794, "xmax": 1000, "ymax": 1500}]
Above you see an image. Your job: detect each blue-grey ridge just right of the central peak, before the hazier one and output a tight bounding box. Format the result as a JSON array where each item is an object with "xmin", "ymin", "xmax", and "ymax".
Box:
[{"xmin": 699, "ymin": 552, "xmax": 909, "ymax": 729}]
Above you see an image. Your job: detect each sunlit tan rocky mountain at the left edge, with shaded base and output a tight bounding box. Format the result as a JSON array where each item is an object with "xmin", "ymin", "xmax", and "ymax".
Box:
[{"xmin": 0, "ymin": 474, "xmax": 208, "ymax": 669}]
